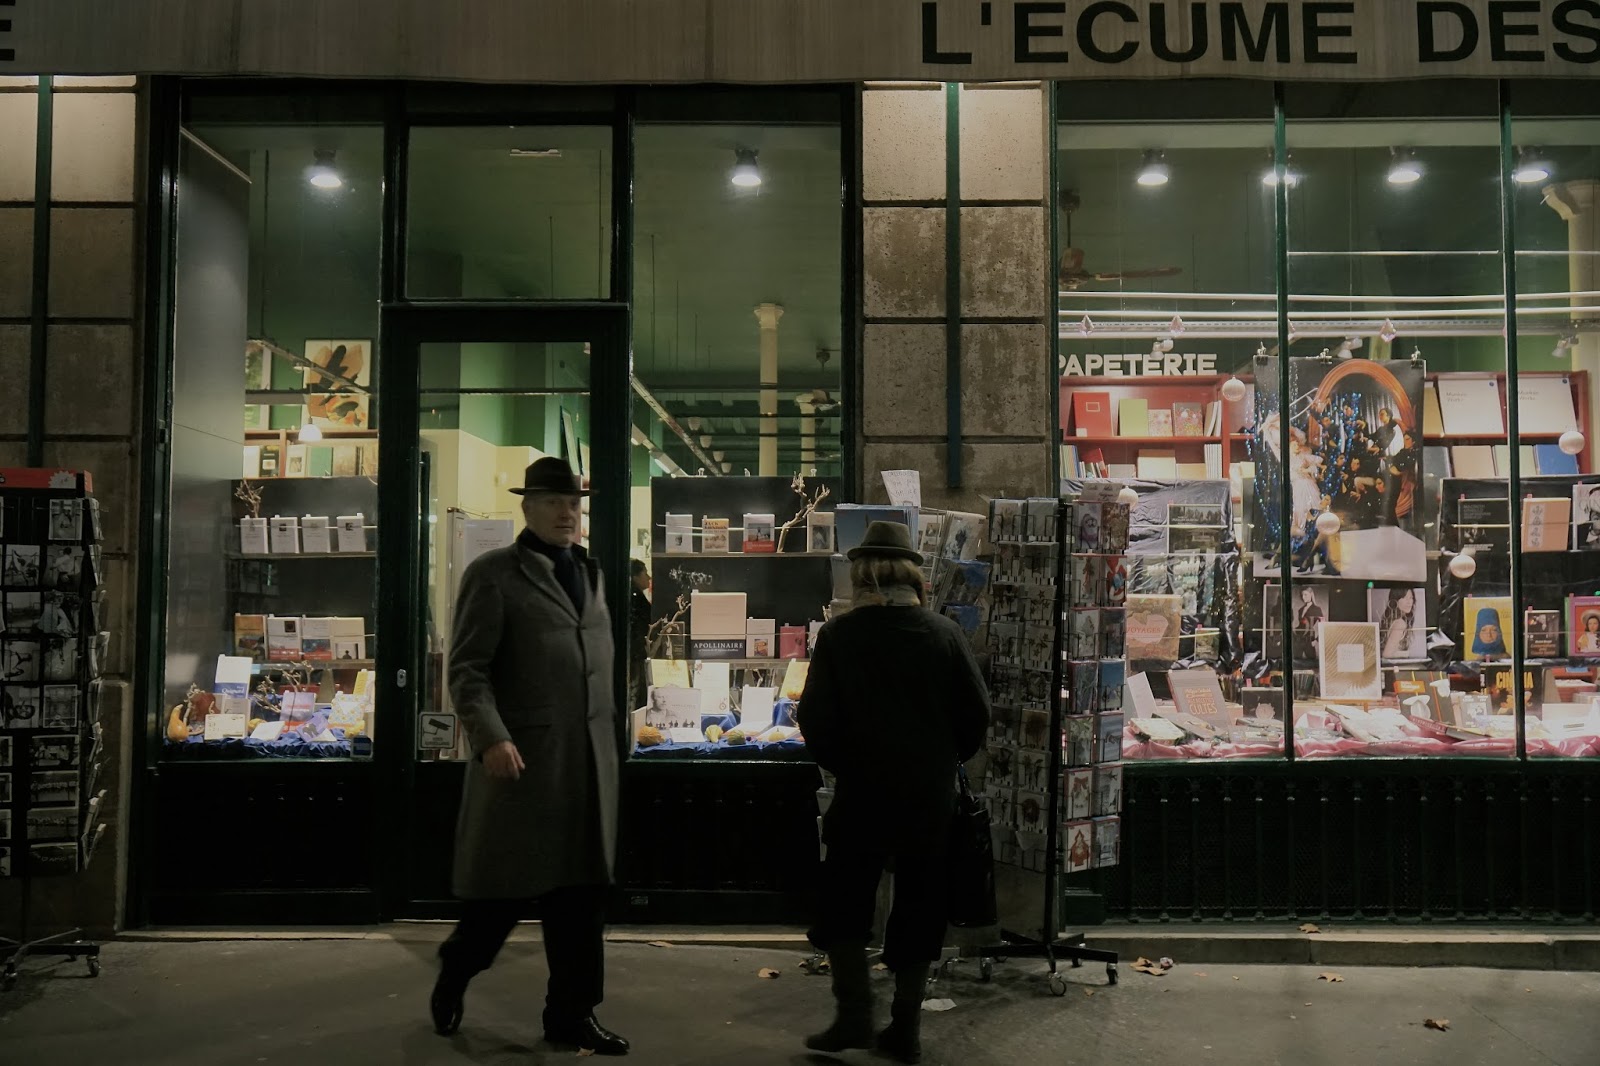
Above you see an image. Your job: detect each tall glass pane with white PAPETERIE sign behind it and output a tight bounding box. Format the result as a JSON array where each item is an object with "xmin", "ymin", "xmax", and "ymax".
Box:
[{"xmin": 1056, "ymin": 83, "xmax": 1285, "ymax": 759}]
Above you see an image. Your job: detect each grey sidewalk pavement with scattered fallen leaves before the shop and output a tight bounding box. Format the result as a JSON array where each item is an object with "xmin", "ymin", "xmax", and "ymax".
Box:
[{"xmin": 0, "ymin": 927, "xmax": 1600, "ymax": 1066}]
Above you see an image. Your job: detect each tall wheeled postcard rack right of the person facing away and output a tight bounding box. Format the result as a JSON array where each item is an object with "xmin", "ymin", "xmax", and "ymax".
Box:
[{"xmin": 982, "ymin": 482, "xmax": 1128, "ymax": 996}]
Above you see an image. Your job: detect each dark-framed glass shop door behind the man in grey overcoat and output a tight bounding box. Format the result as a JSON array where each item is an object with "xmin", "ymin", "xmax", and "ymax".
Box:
[{"xmin": 378, "ymin": 304, "xmax": 630, "ymax": 919}]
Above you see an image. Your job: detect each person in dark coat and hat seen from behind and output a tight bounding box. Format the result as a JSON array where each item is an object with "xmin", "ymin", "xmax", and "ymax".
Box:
[{"xmin": 798, "ymin": 522, "xmax": 990, "ymax": 1063}]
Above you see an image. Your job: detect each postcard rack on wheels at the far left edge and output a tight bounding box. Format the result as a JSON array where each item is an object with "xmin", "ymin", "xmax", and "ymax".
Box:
[{"xmin": 0, "ymin": 469, "xmax": 110, "ymax": 989}]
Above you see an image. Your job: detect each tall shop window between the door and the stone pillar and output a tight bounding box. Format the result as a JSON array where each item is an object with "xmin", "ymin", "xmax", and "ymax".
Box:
[{"xmin": 627, "ymin": 123, "xmax": 843, "ymax": 759}]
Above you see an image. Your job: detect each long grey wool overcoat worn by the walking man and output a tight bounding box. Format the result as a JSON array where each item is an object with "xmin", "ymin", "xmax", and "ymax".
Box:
[{"xmin": 450, "ymin": 544, "xmax": 621, "ymax": 900}]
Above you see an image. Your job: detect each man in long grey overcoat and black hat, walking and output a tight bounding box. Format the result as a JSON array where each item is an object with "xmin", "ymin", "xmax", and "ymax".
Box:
[{"xmin": 430, "ymin": 458, "xmax": 629, "ymax": 1055}]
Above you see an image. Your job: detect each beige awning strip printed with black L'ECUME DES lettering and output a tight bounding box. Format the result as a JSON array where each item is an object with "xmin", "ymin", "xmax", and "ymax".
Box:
[{"xmin": 0, "ymin": 0, "xmax": 1600, "ymax": 83}]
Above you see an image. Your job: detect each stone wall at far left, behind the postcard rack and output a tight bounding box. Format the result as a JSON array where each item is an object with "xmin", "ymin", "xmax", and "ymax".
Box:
[{"xmin": 0, "ymin": 77, "xmax": 142, "ymax": 933}]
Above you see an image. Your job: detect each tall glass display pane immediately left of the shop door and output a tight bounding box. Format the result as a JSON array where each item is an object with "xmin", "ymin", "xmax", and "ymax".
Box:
[{"xmin": 162, "ymin": 125, "xmax": 382, "ymax": 759}]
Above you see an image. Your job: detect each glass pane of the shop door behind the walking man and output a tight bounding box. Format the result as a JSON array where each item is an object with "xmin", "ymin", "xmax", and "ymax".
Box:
[{"xmin": 418, "ymin": 343, "xmax": 592, "ymax": 760}]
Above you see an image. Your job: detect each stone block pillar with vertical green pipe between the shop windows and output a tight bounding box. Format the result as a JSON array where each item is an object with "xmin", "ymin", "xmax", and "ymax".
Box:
[{"xmin": 861, "ymin": 82, "xmax": 1054, "ymax": 511}]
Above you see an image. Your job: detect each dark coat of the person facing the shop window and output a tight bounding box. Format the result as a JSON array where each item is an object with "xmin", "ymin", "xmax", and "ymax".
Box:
[{"xmin": 798, "ymin": 607, "xmax": 990, "ymax": 852}]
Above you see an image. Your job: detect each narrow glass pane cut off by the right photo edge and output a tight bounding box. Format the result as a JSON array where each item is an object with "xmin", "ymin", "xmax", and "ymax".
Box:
[{"xmin": 1512, "ymin": 85, "xmax": 1600, "ymax": 757}]
